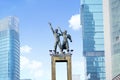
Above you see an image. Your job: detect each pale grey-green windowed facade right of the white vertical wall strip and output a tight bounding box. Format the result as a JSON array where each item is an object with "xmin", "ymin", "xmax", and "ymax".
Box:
[{"xmin": 109, "ymin": 0, "xmax": 120, "ymax": 80}]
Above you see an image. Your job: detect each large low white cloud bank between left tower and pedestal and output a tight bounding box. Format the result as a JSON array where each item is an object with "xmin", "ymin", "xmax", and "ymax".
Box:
[{"xmin": 20, "ymin": 56, "xmax": 44, "ymax": 80}]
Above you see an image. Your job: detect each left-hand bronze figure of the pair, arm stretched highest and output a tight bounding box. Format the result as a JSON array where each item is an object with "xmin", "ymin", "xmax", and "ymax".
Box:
[{"xmin": 48, "ymin": 23, "xmax": 62, "ymax": 54}]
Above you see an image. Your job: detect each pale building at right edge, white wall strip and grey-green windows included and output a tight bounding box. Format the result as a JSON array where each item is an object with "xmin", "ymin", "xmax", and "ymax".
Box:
[{"xmin": 103, "ymin": 0, "xmax": 120, "ymax": 80}]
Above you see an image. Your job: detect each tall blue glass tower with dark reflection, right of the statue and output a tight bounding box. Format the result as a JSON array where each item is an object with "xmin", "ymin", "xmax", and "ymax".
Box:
[{"xmin": 81, "ymin": 0, "xmax": 105, "ymax": 80}]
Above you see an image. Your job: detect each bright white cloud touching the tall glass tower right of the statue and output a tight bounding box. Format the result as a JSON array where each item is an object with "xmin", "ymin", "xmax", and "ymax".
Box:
[{"xmin": 68, "ymin": 14, "xmax": 81, "ymax": 30}]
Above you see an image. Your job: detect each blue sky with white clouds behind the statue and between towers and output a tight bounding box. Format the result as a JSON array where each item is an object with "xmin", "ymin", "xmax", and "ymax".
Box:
[{"xmin": 0, "ymin": 0, "xmax": 85, "ymax": 80}]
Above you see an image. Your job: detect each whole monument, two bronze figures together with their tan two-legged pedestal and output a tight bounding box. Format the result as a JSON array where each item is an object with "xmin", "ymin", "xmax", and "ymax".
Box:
[{"xmin": 49, "ymin": 23, "xmax": 73, "ymax": 80}]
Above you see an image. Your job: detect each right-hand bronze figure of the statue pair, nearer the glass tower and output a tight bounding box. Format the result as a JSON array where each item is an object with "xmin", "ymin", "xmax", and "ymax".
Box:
[{"xmin": 58, "ymin": 27, "xmax": 72, "ymax": 52}]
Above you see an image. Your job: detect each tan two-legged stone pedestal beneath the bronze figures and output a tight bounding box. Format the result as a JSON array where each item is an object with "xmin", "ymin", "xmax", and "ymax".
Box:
[{"xmin": 50, "ymin": 53, "xmax": 72, "ymax": 80}]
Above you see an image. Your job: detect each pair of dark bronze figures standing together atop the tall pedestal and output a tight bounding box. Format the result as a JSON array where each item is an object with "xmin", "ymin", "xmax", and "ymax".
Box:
[{"xmin": 49, "ymin": 23, "xmax": 72, "ymax": 54}]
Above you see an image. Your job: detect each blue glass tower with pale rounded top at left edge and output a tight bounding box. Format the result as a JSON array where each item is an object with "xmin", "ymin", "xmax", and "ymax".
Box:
[{"xmin": 0, "ymin": 16, "xmax": 20, "ymax": 80}]
